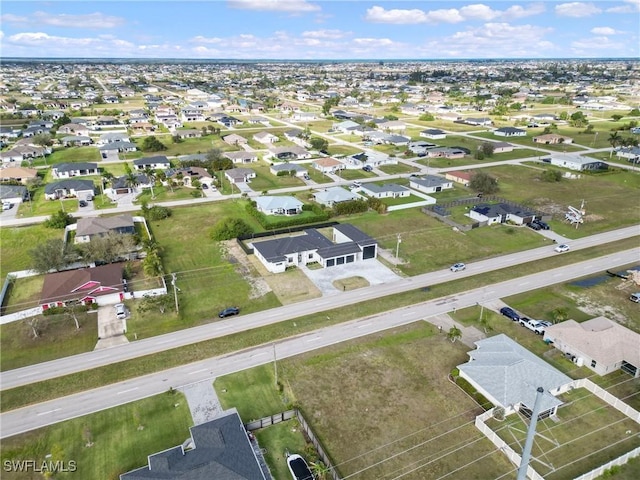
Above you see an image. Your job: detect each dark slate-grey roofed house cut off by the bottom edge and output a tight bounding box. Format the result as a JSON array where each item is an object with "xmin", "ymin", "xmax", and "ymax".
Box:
[{"xmin": 120, "ymin": 408, "xmax": 270, "ymax": 480}]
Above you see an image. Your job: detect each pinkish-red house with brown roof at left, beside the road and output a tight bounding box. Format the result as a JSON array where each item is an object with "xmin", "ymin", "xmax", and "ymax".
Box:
[{"xmin": 40, "ymin": 263, "xmax": 124, "ymax": 310}]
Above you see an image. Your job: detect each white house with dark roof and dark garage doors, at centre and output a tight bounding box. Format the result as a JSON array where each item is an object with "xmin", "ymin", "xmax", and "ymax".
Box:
[{"xmin": 252, "ymin": 224, "xmax": 378, "ymax": 273}]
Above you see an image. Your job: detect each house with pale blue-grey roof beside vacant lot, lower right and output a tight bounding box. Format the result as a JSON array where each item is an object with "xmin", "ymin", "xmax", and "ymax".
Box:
[{"xmin": 458, "ymin": 333, "xmax": 572, "ymax": 418}]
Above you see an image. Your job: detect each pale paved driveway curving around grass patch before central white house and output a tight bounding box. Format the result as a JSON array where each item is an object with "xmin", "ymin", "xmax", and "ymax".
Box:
[{"xmin": 301, "ymin": 259, "xmax": 401, "ymax": 296}]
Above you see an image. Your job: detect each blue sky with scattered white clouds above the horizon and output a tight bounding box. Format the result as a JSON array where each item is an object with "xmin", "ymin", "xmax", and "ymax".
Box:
[{"xmin": 0, "ymin": 0, "xmax": 640, "ymax": 60}]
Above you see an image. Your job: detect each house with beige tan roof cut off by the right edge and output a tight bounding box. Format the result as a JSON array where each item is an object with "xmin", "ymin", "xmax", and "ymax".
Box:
[{"xmin": 544, "ymin": 317, "xmax": 640, "ymax": 378}]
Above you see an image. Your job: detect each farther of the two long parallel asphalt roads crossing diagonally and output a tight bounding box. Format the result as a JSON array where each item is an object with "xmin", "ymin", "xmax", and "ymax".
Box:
[{"xmin": 0, "ymin": 226, "xmax": 640, "ymax": 390}]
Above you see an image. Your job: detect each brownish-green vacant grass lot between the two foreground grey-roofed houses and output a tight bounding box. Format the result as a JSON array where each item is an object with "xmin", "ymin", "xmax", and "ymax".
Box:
[{"xmin": 216, "ymin": 322, "xmax": 512, "ymax": 479}]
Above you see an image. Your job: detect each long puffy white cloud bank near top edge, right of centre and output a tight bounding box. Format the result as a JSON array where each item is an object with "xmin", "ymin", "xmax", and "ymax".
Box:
[{"xmin": 365, "ymin": 3, "xmax": 545, "ymax": 25}]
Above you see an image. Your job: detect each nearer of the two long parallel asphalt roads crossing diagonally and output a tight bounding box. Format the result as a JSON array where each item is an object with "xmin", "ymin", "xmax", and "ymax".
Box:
[{"xmin": 0, "ymin": 248, "xmax": 640, "ymax": 438}]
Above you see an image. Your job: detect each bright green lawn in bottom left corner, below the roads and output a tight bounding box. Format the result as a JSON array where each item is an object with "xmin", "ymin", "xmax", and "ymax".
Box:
[{"xmin": 1, "ymin": 393, "xmax": 193, "ymax": 480}]
